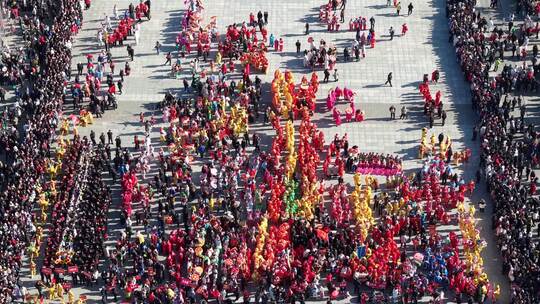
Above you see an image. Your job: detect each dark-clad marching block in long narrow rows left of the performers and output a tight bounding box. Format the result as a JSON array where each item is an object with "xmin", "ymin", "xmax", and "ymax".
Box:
[{"xmin": 39, "ymin": 136, "xmax": 111, "ymax": 288}]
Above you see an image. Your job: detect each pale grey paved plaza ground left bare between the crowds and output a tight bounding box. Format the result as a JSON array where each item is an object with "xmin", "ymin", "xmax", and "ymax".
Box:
[{"xmin": 8, "ymin": 0, "xmax": 524, "ymax": 303}]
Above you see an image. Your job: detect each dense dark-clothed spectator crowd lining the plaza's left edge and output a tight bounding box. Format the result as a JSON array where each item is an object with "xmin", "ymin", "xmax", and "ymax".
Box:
[{"xmin": 0, "ymin": 0, "xmax": 92, "ymax": 302}]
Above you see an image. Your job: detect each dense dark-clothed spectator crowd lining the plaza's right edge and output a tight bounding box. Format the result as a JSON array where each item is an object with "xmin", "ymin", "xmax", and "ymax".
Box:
[{"xmin": 446, "ymin": 0, "xmax": 540, "ymax": 303}]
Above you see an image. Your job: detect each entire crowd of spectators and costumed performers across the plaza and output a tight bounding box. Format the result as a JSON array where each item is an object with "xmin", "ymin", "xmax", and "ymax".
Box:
[{"xmin": 0, "ymin": 0, "xmax": 540, "ymax": 303}]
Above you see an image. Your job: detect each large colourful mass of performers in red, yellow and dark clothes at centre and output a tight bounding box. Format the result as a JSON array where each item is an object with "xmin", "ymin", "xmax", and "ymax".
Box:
[{"xmin": 24, "ymin": 1, "xmax": 498, "ymax": 303}]
